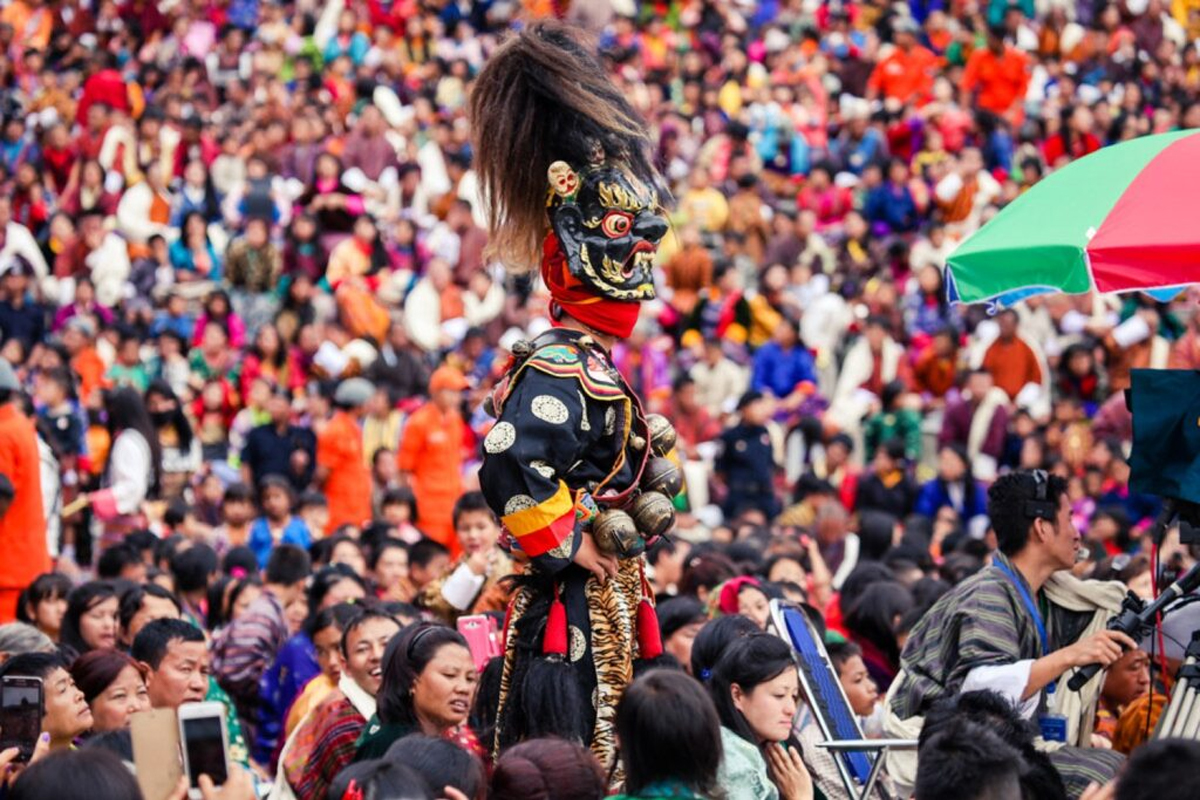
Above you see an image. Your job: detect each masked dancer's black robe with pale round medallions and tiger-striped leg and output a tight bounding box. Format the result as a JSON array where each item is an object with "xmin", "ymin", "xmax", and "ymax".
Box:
[{"xmin": 480, "ymin": 329, "xmax": 647, "ymax": 766}]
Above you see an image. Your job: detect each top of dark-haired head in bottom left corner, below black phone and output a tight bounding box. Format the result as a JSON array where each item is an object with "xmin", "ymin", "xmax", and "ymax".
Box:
[{"xmin": 7, "ymin": 747, "xmax": 142, "ymax": 800}]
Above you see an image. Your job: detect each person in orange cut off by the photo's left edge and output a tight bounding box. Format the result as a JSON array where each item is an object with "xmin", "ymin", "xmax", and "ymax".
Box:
[{"xmin": 0, "ymin": 359, "xmax": 50, "ymax": 624}]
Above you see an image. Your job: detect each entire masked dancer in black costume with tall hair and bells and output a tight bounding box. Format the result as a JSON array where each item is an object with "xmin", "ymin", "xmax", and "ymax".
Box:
[{"xmin": 469, "ymin": 22, "xmax": 679, "ymax": 769}]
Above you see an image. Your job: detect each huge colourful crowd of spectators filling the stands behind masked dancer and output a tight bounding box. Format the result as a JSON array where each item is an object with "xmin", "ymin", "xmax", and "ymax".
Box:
[{"xmin": 0, "ymin": 0, "xmax": 1200, "ymax": 800}]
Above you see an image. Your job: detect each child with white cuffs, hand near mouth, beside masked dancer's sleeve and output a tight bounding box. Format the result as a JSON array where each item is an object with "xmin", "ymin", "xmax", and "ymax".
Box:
[{"xmin": 419, "ymin": 492, "xmax": 514, "ymax": 625}]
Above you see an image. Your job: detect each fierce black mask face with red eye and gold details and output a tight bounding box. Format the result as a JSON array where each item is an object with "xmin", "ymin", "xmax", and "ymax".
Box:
[{"xmin": 548, "ymin": 161, "xmax": 667, "ymax": 302}]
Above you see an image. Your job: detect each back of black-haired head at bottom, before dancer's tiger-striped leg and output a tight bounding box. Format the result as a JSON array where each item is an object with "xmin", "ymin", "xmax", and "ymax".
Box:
[{"xmin": 616, "ymin": 671, "xmax": 720, "ymax": 796}]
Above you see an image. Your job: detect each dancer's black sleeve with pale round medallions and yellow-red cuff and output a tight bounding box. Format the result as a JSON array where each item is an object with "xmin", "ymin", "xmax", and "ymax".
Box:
[{"xmin": 480, "ymin": 369, "xmax": 590, "ymax": 572}]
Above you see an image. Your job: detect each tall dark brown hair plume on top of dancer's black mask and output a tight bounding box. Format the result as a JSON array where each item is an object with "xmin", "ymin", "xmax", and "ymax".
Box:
[{"xmin": 467, "ymin": 20, "xmax": 666, "ymax": 271}]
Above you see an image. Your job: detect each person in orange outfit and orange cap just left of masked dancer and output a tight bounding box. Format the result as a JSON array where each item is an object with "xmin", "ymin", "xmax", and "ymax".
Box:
[{"xmin": 397, "ymin": 367, "xmax": 469, "ymax": 558}]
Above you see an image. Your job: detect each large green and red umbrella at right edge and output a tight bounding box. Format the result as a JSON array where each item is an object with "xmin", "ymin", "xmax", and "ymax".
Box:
[{"xmin": 947, "ymin": 128, "xmax": 1200, "ymax": 306}]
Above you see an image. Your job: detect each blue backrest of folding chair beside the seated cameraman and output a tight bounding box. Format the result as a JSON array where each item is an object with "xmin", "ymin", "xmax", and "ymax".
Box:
[{"xmin": 770, "ymin": 600, "xmax": 878, "ymax": 787}]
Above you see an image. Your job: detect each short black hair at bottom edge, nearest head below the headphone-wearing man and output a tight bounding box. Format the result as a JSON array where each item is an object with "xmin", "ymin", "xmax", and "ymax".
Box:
[{"xmin": 914, "ymin": 720, "xmax": 1021, "ymax": 800}]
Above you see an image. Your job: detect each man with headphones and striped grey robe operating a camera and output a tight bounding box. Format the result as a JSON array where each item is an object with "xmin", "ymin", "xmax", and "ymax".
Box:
[{"xmin": 887, "ymin": 470, "xmax": 1136, "ymax": 796}]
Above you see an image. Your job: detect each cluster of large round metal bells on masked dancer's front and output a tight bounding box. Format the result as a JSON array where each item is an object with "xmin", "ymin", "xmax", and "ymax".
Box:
[{"xmin": 592, "ymin": 414, "xmax": 683, "ymax": 558}]
